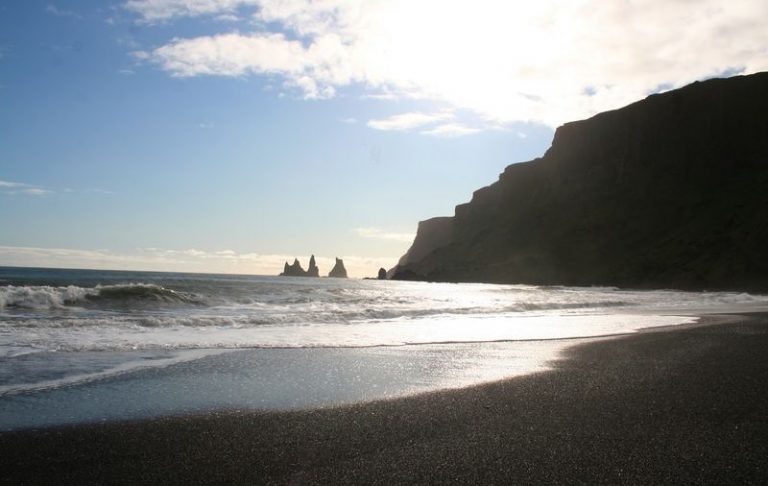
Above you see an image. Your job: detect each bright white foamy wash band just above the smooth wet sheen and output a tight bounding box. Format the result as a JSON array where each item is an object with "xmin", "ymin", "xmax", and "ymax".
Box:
[{"xmin": 0, "ymin": 314, "xmax": 695, "ymax": 352}]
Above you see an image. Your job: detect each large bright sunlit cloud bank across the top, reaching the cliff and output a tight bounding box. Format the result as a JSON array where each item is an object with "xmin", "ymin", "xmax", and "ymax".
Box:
[{"xmin": 125, "ymin": 0, "xmax": 768, "ymax": 130}]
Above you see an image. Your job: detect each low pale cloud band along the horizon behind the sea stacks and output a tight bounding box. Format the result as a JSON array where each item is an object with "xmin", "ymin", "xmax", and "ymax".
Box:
[{"xmin": 0, "ymin": 246, "xmax": 397, "ymax": 277}]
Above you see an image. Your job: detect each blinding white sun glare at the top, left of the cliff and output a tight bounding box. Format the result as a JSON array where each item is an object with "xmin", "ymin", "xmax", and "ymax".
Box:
[{"xmin": 370, "ymin": 2, "xmax": 556, "ymax": 119}]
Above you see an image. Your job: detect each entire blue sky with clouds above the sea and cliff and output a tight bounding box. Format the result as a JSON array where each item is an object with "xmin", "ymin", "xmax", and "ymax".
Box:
[{"xmin": 0, "ymin": 0, "xmax": 768, "ymax": 277}]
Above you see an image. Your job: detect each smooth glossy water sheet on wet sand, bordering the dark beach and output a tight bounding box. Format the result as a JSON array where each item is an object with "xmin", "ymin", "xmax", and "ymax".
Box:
[{"xmin": 0, "ymin": 339, "xmax": 587, "ymax": 431}]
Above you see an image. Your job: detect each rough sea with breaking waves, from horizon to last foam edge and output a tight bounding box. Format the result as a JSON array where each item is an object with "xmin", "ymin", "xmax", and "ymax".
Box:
[{"xmin": 0, "ymin": 270, "xmax": 768, "ymax": 394}]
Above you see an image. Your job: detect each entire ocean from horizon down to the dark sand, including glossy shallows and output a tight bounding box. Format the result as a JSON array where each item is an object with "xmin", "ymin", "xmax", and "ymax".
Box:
[{"xmin": 0, "ymin": 267, "xmax": 768, "ymax": 429}]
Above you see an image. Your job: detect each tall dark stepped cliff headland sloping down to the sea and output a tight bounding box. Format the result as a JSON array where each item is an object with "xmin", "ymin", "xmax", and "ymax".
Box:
[{"xmin": 390, "ymin": 73, "xmax": 768, "ymax": 291}]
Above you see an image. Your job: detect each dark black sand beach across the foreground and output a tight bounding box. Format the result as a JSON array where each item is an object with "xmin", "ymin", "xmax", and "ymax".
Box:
[{"xmin": 0, "ymin": 316, "xmax": 768, "ymax": 484}]
